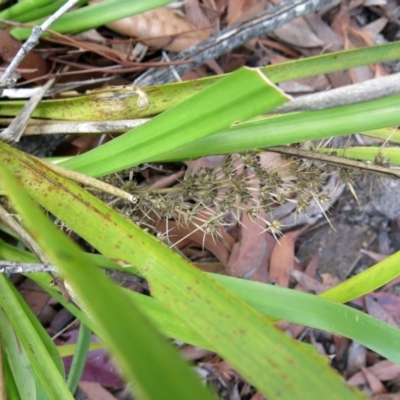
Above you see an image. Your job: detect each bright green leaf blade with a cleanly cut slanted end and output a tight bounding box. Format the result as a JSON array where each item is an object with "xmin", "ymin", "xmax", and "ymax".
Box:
[{"xmin": 61, "ymin": 68, "xmax": 289, "ymax": 176}]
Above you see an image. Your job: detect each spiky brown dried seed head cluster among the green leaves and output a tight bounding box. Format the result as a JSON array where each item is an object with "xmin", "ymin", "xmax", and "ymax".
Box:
[{"xmin": 90, "ymin": 151, "xmax": 329, "ymax": 242}]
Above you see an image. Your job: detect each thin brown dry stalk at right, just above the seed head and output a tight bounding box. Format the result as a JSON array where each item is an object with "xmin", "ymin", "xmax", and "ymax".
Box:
[{"xmin": 268, "ymin": 146, "xmax": 400, "ymax": 179}]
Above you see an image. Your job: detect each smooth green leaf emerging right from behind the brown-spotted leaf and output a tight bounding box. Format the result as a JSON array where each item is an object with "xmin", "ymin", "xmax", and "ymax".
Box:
[{"xmin": 213, "ymin": 274, "xmax": 400, "ymax": 364}]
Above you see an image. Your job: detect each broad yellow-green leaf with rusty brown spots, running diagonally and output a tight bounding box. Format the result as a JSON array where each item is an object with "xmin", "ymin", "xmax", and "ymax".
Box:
[{"xmin": 0, "ymin": 143, "xmax": 362, "ymax": 399}]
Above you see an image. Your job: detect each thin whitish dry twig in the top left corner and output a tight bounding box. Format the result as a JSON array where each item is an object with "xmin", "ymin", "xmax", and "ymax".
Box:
[{"xmin": 0, "ymin": 0, "xmax": 79, "ymax": 87}]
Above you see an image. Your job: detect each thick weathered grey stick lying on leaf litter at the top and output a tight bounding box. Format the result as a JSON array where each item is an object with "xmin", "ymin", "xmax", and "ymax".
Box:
[{"xmin": 135, "ymin": 0, "xmax": 331, "ymax": 86}]
